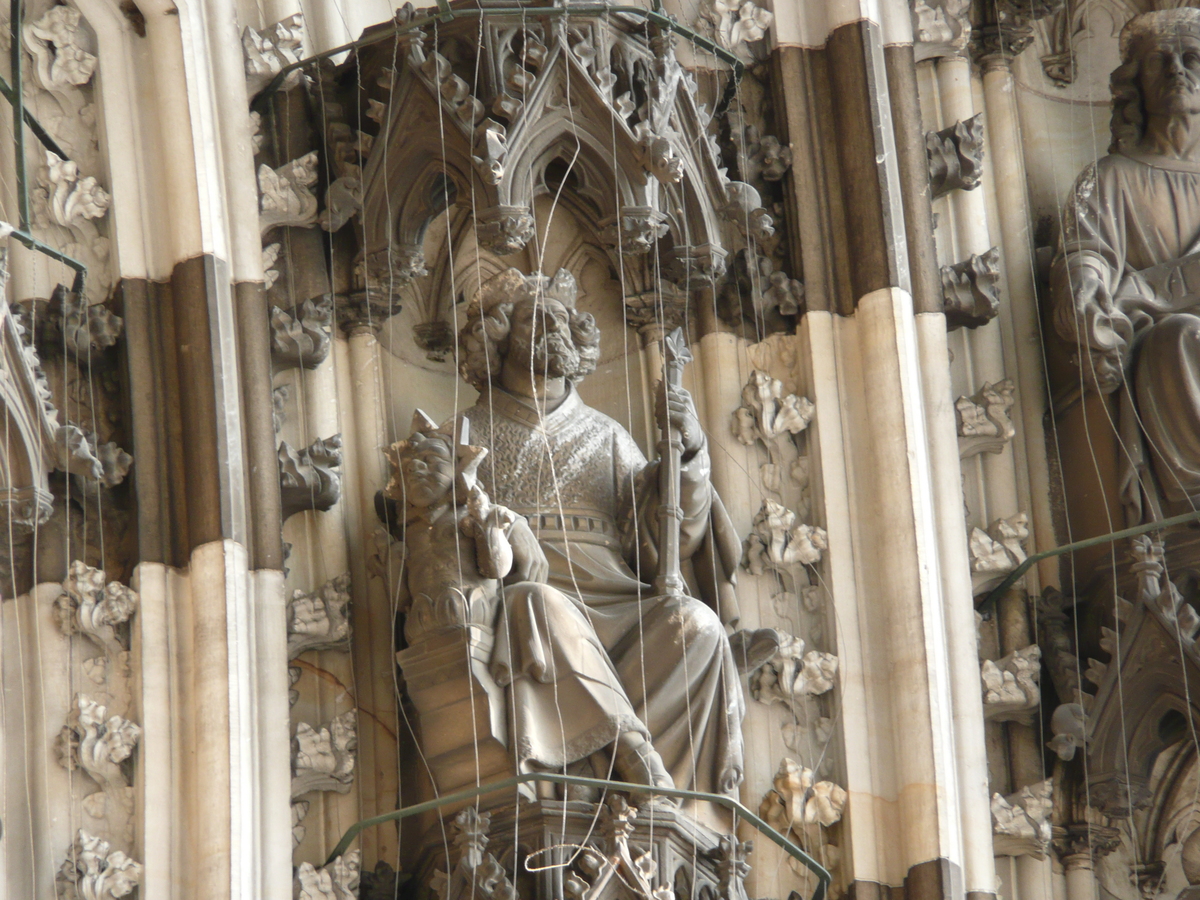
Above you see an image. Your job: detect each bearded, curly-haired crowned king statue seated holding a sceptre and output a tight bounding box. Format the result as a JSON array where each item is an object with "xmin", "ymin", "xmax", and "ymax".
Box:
[{"xmin": 457, "ymin": 269, "xmax": 745, "ymax": 793}]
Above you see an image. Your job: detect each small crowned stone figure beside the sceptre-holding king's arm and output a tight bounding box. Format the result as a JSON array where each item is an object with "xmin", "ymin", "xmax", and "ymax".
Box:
[{"xmin": 384, "ymin": 409, "xmax": 523, "ymax": 643}]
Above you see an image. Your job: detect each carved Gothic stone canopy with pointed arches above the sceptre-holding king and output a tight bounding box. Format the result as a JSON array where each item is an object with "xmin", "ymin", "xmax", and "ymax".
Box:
[{"xmin": 362, "ymin": 7, "xmax": 770, "ymax": 300}]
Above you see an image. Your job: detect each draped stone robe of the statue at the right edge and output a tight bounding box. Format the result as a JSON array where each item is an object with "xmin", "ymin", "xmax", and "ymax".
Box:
[{"xmin": 1052, "ymin": 152, "xmax": 1200, "ymax": 523}]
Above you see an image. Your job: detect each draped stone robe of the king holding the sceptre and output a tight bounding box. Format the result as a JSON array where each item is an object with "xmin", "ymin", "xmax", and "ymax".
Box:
[{"xmin": 463, "ymin": 388, "xmax": 745, "ymax": 792}]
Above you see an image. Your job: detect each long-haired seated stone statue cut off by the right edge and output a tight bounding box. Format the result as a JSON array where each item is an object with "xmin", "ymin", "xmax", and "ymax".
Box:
[{"xmin": 1051, "ymin": 8, "xmax": 1200, "ymax": 524}]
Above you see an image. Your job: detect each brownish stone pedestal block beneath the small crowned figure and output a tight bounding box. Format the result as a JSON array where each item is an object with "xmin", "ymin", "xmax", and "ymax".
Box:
[{"xmin": 396, "ymin": 625, "xmax": 516, "ymax": 794}]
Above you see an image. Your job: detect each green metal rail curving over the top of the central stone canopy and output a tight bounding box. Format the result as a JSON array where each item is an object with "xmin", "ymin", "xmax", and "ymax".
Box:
[{"xmin": 249, "ymin": 0, "xmax": 745, "ymax": 118}]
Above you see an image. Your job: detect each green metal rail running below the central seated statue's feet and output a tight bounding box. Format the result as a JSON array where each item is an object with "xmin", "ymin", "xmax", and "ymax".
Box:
[{"xmin": 325, "ymin": 772, "xmax": 833, "ymax": 900}]
